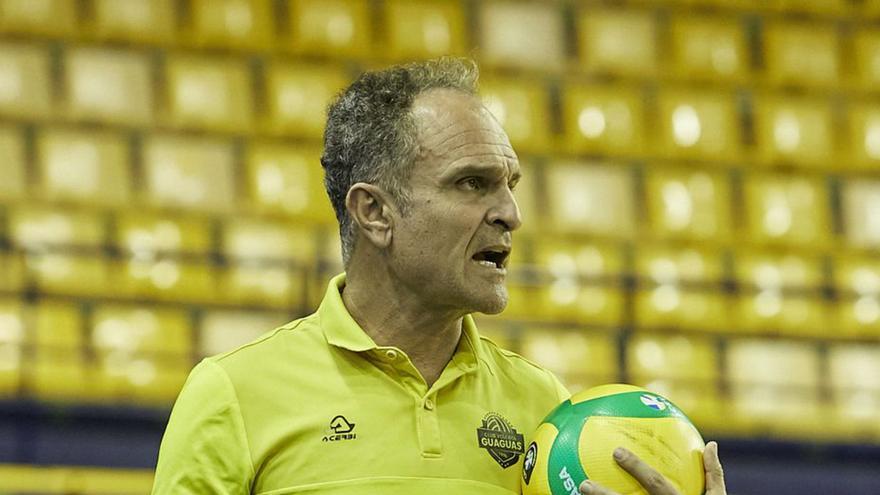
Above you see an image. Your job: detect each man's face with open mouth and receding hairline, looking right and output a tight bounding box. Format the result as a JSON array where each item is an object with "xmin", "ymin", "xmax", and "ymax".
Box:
[{"xmin": 389, "ymin": 90, "xmax": 521, "ymax": 314}]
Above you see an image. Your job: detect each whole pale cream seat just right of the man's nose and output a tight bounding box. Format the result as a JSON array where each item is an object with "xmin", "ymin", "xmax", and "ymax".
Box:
[{"xmin": 544, "ymin": 162, "xmax": 635, "ymax": 237}]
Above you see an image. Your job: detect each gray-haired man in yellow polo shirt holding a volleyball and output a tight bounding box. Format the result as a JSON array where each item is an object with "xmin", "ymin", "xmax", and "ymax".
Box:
[{"xmin": 153, "ymin": 60, "xmax": 724, "ymax": 495}]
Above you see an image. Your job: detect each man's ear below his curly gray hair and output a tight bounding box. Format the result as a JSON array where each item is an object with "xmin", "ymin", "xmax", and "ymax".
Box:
[{"xmin": 345, "ymin": 182, "xmax": 393, "ymax": 248}]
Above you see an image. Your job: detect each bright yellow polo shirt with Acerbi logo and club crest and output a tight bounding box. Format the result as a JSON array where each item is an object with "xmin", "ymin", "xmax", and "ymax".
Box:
[{"xmin": 153, "ymin": 275, "xmax": 568, "ymax": 495}]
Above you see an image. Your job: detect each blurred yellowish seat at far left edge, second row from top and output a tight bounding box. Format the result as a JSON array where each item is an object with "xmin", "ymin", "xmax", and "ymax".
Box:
[{"xmin": 0, "ymin": 42, "xmax": 52, "ymax": 119}]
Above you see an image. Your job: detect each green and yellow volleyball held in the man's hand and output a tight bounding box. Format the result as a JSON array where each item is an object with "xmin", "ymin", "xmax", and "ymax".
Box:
[{"xmin": 522, "ymin": 384, "xmax": 705, "ymax": 495}]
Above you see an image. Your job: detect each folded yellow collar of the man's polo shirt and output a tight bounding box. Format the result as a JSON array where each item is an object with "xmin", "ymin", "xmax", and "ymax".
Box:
[{"xmin": 318, "ymin": 273, "xmax": 483, "ymax": 369}]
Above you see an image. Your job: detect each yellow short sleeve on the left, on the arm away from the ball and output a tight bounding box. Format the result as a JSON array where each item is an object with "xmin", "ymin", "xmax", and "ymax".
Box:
[{"xmin": 153, "ymin": 359, "xmax": 254, "ymax": 495}]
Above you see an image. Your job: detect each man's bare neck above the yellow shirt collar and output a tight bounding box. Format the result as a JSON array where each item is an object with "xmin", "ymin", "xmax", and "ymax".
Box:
[{"xmin": 342, "ymin": 262, "xmax": 464, "ymax": 387}]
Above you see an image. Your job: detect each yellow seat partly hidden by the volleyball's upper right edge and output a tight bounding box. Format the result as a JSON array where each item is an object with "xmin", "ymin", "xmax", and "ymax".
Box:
[{"xmin": 626, "ymin": 334, "xmax": 719, "ymax": 426}]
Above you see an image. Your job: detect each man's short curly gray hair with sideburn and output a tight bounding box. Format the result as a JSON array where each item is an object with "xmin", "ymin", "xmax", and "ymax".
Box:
[{"xmin": 321, "ymin": 58, "xmax": 479, "ymax": 267}]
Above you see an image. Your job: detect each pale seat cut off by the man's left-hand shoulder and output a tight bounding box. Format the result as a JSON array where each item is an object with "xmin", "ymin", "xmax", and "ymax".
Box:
[{"xmin": 196, "ymin": 310, "xmax": 292, "ymax": 356}]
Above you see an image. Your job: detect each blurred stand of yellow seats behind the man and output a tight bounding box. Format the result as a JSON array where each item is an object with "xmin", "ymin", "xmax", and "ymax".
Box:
[{"xmin": 0, "ymin": 0, "xmax": 880, "ymax": 495}]
